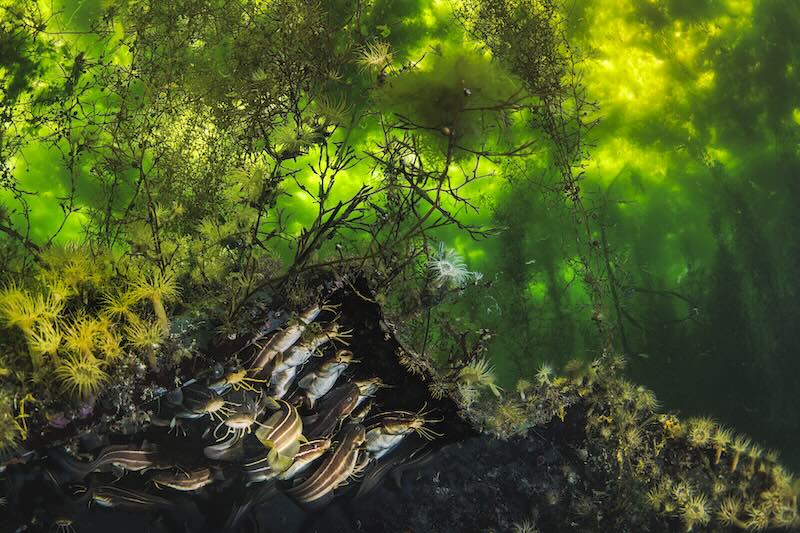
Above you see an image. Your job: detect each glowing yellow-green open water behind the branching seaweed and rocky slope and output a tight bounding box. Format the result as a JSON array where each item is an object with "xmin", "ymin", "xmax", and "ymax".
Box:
[{"xmin": 0, "ymin": 0, "xmax": 800, "ymax": 467}]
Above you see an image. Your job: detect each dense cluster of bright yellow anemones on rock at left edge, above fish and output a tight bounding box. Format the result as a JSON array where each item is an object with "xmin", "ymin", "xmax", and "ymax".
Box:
[{"xmin": 0, "ymin": 246, "xmax": 179, "ymax": 398}]
